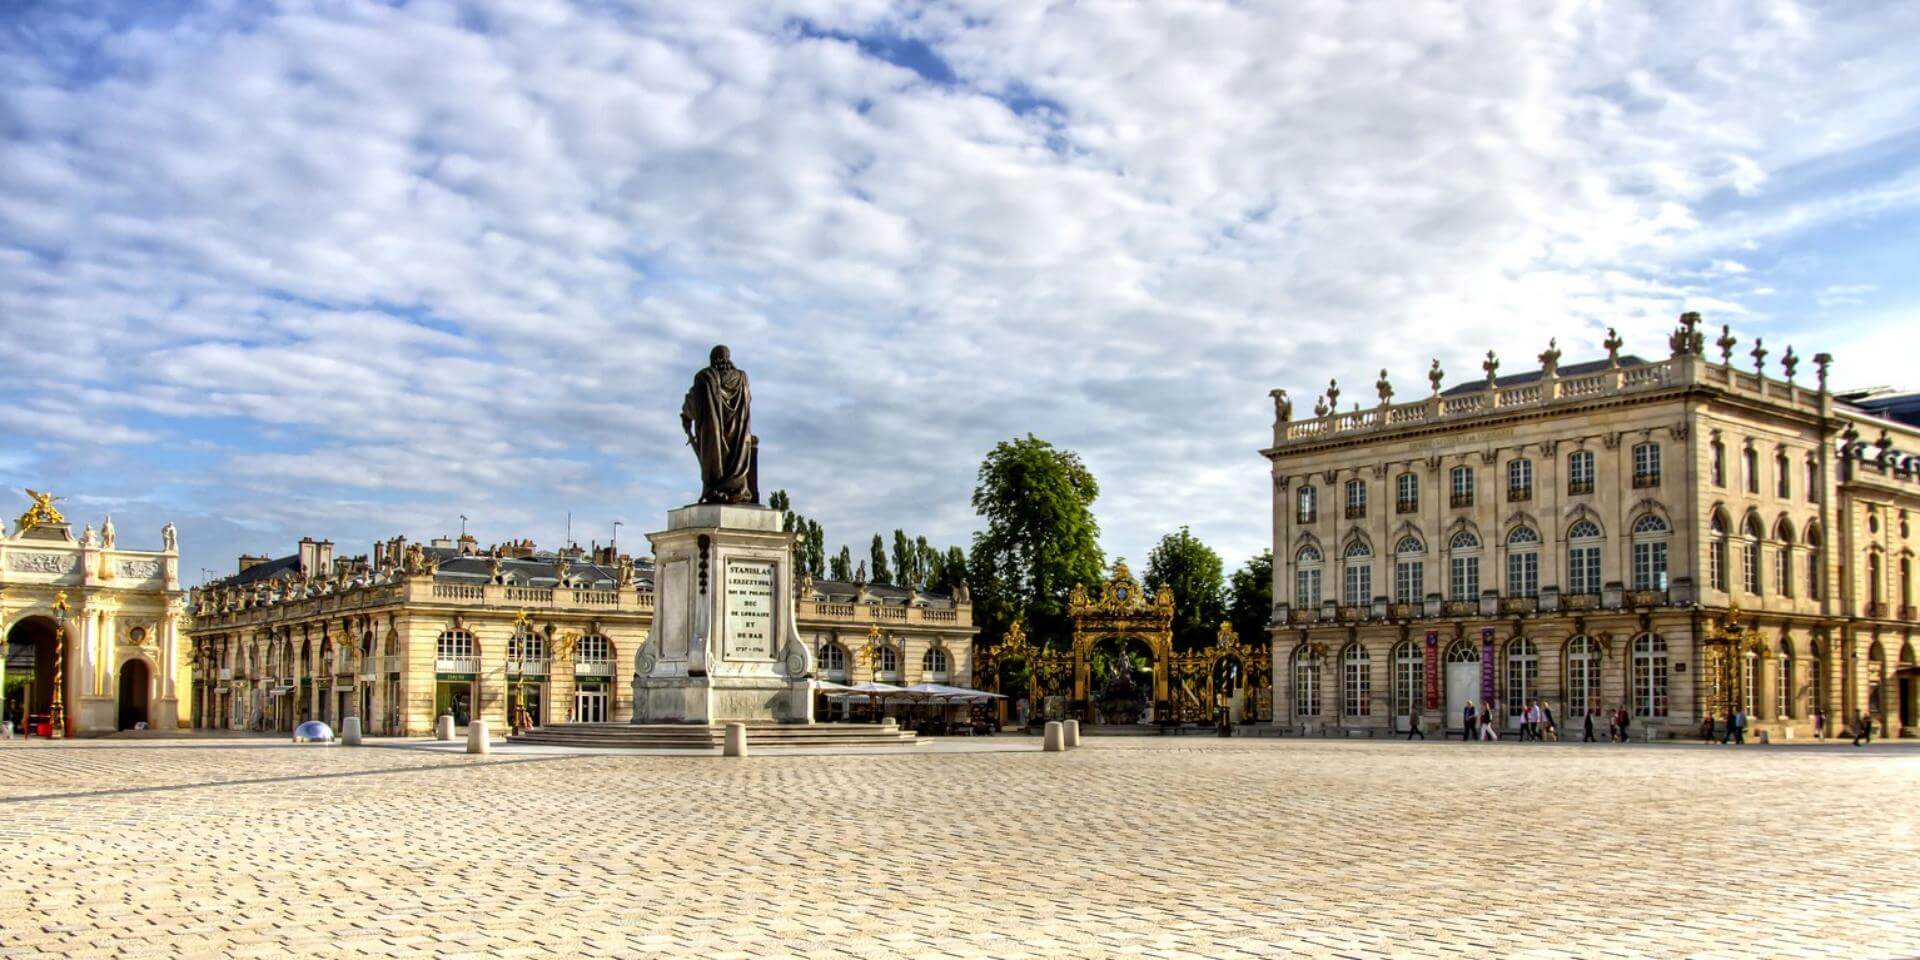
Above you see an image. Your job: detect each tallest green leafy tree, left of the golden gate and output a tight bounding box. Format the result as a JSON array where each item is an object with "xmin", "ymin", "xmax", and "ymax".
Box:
[{"xmin": 968, "ymin": 434, "xmax": 1106, "ymax": 643}]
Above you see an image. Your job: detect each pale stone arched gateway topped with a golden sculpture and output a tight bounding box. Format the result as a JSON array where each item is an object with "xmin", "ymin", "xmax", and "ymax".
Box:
[{"xmin": 0, "ymin": 490, "xmax": 186, "ymax": 735}]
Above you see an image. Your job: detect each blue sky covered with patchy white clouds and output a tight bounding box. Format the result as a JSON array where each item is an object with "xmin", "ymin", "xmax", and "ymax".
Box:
[{"xmin": 0, "ymin": 0, "xmax": 1920, "ymax": 582}]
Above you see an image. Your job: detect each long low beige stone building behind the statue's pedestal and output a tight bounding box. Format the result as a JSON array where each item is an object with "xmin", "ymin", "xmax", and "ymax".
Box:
[{"xmin": 190, "ymin": 536, "xmax": 977, "ymax": 735}]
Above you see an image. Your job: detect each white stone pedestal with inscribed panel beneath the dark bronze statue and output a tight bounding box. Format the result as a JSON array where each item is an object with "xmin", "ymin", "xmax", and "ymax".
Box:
[{"xmin": 634, "ymin": 503, "xmax": 814, "ymax": 724}]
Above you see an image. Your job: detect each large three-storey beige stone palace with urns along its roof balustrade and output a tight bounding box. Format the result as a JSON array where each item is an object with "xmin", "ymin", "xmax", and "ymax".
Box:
[{"xmin": 1263, "ymin": 313, "xmax": 1920, "ymax": 737}]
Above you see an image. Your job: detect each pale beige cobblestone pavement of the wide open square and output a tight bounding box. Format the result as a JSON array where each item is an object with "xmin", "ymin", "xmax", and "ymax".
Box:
[{"xmin": 0, "ymin": 737, "xmax": 1920, "ymax": 958}]
